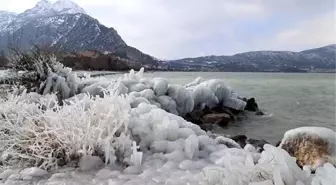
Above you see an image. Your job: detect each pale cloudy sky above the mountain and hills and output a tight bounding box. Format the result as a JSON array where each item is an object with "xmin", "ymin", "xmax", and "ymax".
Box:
[{"xmin": 0, "ymin": 0, "xmax": 336, "ymax": 59}]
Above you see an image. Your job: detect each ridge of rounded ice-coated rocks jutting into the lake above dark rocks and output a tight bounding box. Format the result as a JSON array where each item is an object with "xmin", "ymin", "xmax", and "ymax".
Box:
[{"xmin": 79, "ymin": 69, "xmax": 246, "ymax": 116}]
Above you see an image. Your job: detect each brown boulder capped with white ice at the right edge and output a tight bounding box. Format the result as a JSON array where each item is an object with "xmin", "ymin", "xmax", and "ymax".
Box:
[{"xmin": 279, "ymin": 127, "xmax": 336, "ymax": 170}]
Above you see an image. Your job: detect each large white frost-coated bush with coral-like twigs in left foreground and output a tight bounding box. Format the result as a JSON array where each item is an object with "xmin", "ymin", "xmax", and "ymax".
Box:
[{"xmin": 0, "ymin": 90, "xmax": 132, "ymax": 169}]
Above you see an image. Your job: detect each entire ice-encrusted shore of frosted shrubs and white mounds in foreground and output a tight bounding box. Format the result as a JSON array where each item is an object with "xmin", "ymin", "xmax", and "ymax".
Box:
[{"xmin": 0, "ymin": 55, "xmax": 336, "ymax": 185}]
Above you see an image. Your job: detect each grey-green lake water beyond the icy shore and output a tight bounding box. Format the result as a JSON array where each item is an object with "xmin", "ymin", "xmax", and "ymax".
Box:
[{"xmin": 115, "ymin": 72, "xmax": 336, "ymax": 143}]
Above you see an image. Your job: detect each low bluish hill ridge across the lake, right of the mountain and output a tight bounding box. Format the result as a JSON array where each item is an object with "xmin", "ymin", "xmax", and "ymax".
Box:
[{"xmin": 162, "ymin": 45, "xmax": 336, "ymax": 72}]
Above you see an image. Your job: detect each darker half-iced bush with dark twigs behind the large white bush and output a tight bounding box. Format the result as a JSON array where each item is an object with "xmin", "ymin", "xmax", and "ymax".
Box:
[{"xmin": 10, "ymin": 50, "xmax": 77, "ymax": 100}]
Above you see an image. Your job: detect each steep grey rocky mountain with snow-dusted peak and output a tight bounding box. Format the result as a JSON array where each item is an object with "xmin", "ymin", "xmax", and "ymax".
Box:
[{"xmin": 0, "ymin": 0, "xmax": 156, "ymax": 65}]
